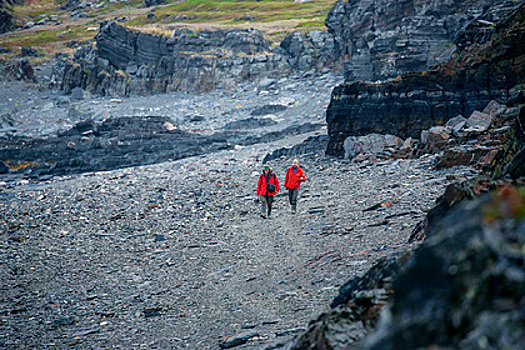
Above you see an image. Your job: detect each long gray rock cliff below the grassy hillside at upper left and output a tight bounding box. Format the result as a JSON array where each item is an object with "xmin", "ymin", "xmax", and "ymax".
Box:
[{"xmin": 55, "ymin": 21, "xmax": 291, "ymax": 95}]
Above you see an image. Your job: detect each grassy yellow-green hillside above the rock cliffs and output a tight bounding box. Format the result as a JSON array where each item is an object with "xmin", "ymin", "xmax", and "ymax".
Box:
[{"xmin": 0, "ymin": 0, "xmax": 335, "ymax": 63}]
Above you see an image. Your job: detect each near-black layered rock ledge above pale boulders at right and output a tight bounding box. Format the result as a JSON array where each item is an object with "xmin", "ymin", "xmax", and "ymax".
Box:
[{"xmin": 326, "ymin": 6, "xmax": 525, "ymax": 156}]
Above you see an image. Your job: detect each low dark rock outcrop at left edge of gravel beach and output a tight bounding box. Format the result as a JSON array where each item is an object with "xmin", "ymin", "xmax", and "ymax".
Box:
[{"xmin": 0, "ymin": 116, "xmax": 232, "ymax": 177}]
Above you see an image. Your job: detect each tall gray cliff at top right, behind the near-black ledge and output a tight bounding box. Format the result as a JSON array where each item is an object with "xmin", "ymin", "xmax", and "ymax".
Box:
[{"xmin": 325, "ymin": 0, "xmax": 523, "ymax": 81}]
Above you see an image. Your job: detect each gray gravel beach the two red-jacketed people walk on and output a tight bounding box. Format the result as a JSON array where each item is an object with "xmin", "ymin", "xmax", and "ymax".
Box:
[{"xmin": 0, "ymin": 135, "xmax": 473, "ymax": 349}]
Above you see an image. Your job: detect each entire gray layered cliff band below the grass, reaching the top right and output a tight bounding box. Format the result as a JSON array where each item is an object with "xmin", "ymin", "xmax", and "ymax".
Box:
[{"xmin": 50, "ymin": 0, "xmax": 525, "ymax": 95}]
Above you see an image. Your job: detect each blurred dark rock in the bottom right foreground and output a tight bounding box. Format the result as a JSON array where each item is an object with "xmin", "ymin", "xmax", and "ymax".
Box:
[{"xmin": 367, "ymin": 187, "xmax": 525, "ymax": 349}]
